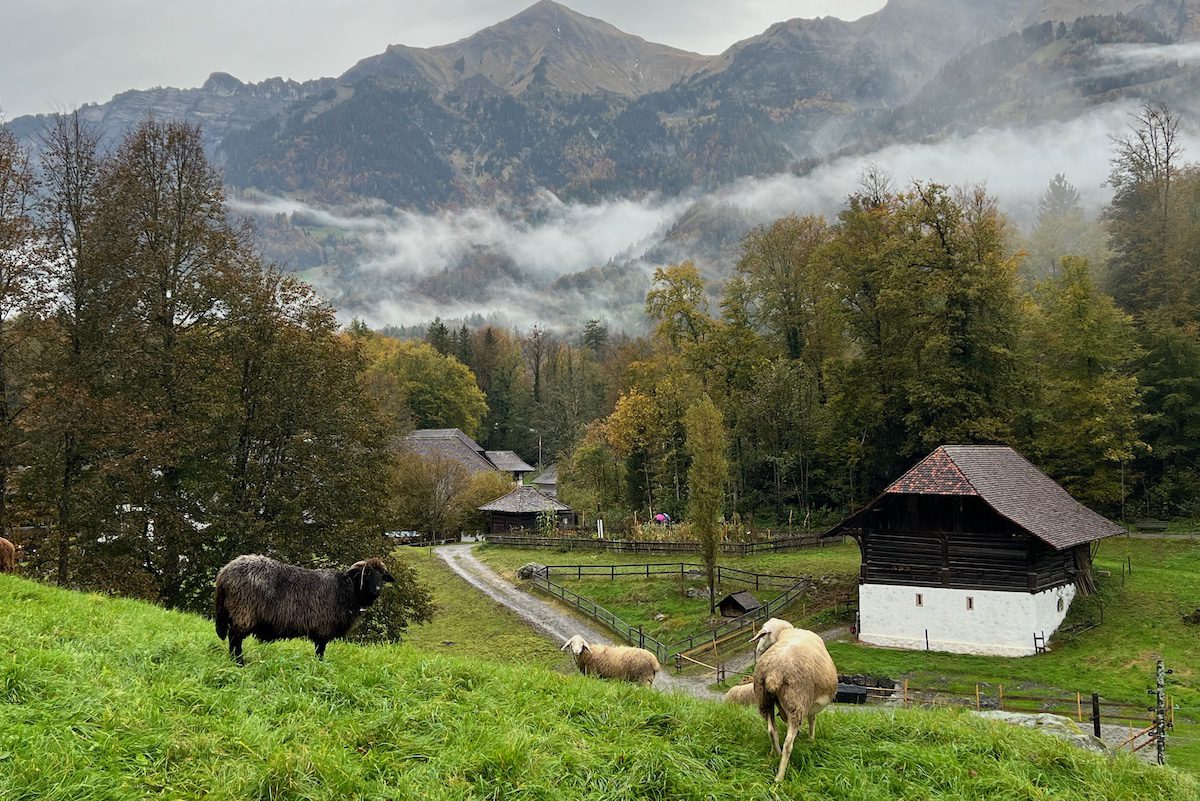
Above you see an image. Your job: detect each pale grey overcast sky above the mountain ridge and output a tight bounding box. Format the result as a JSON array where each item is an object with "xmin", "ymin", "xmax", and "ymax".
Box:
[{"xmin": 0, "ymin": 0, "xmax": 884, "ymax": 119}]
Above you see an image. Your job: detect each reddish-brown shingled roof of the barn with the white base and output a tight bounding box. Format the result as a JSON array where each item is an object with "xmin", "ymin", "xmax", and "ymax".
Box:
[{"xmin": 830, "ymin": 445, "xmax": 1124, "ymax": 550}]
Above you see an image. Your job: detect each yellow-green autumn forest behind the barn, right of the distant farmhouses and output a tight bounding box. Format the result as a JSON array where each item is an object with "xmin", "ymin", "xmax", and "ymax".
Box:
[{"xmin": 418, "ymin": 106, "xmax": 1200, "ymax": 528}]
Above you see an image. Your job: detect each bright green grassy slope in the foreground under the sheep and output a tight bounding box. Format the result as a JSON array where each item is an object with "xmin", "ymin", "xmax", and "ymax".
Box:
[{"xmin": 0, "ymin": 576, "xmax": 1200, "ymax": 801}]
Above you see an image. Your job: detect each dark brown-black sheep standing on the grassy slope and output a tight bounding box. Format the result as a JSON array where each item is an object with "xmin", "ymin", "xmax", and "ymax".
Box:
[{"xmin": 216, "ymin": 556, "xmax": 395, "ymax": 664}]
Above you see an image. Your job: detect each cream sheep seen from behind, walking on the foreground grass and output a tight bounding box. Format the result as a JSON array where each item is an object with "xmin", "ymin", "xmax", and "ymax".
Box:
[{"xmin": 750, "ymin": 618, "xmax": 838, "ymax": 783}]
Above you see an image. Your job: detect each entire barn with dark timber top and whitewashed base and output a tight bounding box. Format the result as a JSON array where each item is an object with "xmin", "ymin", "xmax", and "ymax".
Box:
[{"xmin": 824, "ymin": 445, "xmax": 1124, "ymax": 656}]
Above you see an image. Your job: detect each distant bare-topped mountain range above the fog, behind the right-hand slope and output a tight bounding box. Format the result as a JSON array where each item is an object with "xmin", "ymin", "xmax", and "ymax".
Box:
[{"xmin": 13, "ymin": 0, "xmax": 1166, "ymax": 210}]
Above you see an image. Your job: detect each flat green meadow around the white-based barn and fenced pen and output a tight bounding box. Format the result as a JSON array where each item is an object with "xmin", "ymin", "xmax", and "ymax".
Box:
[{"xmin": 480, "ymin": 537, "xmax": 1200, "ymax": 772}]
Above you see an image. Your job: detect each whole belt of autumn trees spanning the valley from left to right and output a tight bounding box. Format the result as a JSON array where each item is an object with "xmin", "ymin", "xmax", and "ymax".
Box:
[{"xmin": 0, "ymin": 106, "xmax": 1200, "ymax": 608}]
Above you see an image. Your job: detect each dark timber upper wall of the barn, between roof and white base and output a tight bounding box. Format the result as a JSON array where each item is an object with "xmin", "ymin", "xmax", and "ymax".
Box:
[{"xmin": 844, "ymin": 494, "xmax": 1091, "ymax": 592}]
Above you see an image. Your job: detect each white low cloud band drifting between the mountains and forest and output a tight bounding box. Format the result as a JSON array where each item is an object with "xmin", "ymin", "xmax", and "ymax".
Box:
[{"xmin": 234, "ymin": 100, "xmax": 1200, "ymax": 327}]
